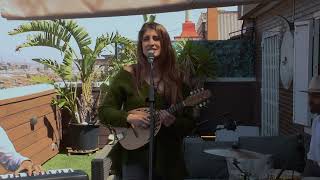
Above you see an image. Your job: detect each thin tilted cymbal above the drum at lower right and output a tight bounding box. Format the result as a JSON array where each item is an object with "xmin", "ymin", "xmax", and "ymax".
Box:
[{"xmin": 204, "ymin": 148, "xmax": 263, "ymax": 159}]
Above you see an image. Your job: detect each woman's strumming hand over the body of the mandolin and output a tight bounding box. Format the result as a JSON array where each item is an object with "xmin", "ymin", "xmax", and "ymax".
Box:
[{"xmin": 127, "ymin": 108, "xmax": 150, "ymax": 128}]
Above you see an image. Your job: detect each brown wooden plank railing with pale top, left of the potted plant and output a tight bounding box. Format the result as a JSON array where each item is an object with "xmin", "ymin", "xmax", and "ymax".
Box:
[{"xmin": 0, "ymin": 85, "xmax": 61, "ymax": 174}]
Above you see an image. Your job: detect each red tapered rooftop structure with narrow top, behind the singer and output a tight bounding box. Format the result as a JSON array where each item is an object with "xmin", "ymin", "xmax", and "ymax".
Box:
[{"xmin": 174, "ymin": 10, "xmax": 201, "ymax": 40}]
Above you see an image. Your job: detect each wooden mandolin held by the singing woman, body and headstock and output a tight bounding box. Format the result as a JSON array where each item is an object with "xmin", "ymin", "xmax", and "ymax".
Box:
[{"xmin": 108, "ymin": 88, "xmax": 211, "ymax": 150}]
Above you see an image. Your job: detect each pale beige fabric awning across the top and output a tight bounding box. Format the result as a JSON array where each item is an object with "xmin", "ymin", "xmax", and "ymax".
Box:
[{"xmin": 0, "ymin": 0, "xmax": 264, "ymax": 20}]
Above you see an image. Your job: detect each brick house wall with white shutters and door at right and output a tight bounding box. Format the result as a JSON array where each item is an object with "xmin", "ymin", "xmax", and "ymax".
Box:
[{"xmin": 238, "ymin": 0, "xmax": 320, "ymax": 136}]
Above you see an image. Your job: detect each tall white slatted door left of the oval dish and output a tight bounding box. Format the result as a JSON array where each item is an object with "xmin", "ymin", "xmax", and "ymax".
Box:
[{"xmin": 261, "ymin": 28, "xmax": 280, "ymax": 136}]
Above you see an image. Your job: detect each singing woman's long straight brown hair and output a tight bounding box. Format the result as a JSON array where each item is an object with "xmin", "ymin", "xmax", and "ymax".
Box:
[{"xmin": 134, "ymin": 22, "xmax": 182, "ymax": 104}]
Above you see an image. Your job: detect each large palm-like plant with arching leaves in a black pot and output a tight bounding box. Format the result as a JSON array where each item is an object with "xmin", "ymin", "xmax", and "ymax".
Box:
[{"xmin": 9, "ymin": 20, "xmax": 132, "ymax": 150}]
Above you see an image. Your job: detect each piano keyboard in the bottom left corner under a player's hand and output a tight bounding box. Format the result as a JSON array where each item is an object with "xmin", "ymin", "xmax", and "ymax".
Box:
[{"xmin": 0, "ymin": 168, "xmax": 89, "ymax": 180}]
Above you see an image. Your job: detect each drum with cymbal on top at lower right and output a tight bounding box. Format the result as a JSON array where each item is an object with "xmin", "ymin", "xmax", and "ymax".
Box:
[{"xmin": 204, "ymin": 148, "xmax": 271, "ymax": 180}]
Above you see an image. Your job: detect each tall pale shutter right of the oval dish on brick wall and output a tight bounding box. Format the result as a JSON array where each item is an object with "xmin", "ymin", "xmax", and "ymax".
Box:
[{"xmin": 293, "ymin": 21, "xmax": 313, "ymax": 126}]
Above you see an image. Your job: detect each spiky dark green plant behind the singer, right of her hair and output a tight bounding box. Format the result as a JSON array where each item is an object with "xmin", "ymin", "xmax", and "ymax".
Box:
[{"xmin": 174, "ymin": 40, "xmax": 217, "ymax": 87}]
